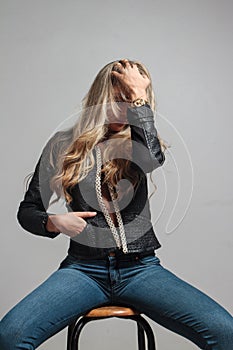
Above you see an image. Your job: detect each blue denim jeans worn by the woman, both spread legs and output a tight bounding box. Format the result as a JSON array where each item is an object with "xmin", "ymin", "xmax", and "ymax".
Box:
[{"xmin": 0, "ymin": 255, "xmax": 233, "ymax": 350}]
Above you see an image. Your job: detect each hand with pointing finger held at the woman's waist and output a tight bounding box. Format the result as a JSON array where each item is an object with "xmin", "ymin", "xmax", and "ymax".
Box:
[{"xmin": 46, "ymin": 211, "xmax": 97, "ymax": 238}]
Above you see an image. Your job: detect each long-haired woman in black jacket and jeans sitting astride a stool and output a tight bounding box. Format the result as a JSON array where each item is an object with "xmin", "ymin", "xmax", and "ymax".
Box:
[{"xmin": 0, "ymin": 59, "xmax": 233, "ymax": 350}]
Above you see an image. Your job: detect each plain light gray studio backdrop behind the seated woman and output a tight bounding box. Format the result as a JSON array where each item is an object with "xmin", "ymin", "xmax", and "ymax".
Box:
[{"xmin": 0, "ymin": 0, "xmax": 233, "ymax": 350}]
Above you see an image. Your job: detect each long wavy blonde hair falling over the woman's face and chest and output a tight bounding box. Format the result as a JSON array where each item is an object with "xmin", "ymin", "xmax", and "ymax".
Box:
[{"xmin": 24, "ymin": 60, "xmax": 168, "ymax": 205}]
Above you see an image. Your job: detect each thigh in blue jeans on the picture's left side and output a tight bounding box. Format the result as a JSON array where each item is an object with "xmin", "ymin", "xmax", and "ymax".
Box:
[{"xmin": 0, "ymin": 254, "xmax": 108, "ymax": 350}]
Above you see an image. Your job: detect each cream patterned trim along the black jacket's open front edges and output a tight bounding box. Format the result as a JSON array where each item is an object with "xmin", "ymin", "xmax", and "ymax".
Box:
[{"xmin": 95, "ymin": 145, "xmax": 128, "ymax": 253}]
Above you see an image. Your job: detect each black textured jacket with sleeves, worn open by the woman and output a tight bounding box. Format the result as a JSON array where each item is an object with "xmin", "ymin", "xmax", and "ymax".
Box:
[{"xmin": 17, "ymin": 104, "xmax": 165, "ymax": 258}]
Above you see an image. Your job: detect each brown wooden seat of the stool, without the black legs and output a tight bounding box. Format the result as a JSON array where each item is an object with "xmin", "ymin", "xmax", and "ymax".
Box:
[{"xmin": 85, "ymin": 306, "xmax": 139, "ymax": 318}]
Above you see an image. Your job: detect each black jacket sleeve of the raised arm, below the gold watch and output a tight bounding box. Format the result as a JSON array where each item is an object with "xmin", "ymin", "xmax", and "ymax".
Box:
[{"xmin": 127, "ymin": 104, "xmax": 165, "ymax": 173}]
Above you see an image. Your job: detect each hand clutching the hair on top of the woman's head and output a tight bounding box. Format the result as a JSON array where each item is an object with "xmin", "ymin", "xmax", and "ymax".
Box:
[{"xmin": 111, "ymin": 60, "xmax": 150, "ymax": 100}]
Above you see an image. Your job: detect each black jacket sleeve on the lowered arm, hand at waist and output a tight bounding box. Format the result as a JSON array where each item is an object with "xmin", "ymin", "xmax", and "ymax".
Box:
[{"xmin": 17, "ymin": 133, "xmax": 60, "ymax": 238}]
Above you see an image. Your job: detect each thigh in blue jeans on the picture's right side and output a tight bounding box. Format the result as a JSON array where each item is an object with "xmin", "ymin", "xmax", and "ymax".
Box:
[{"xmin": 118, "ymin": 257, "xmax": 233, "ymax": 350}]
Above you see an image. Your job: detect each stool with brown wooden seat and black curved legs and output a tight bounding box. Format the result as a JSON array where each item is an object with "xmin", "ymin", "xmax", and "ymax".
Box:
[{"xmin": 67, "ymin": 306, "xmax": 156, "ymax": 350}]
